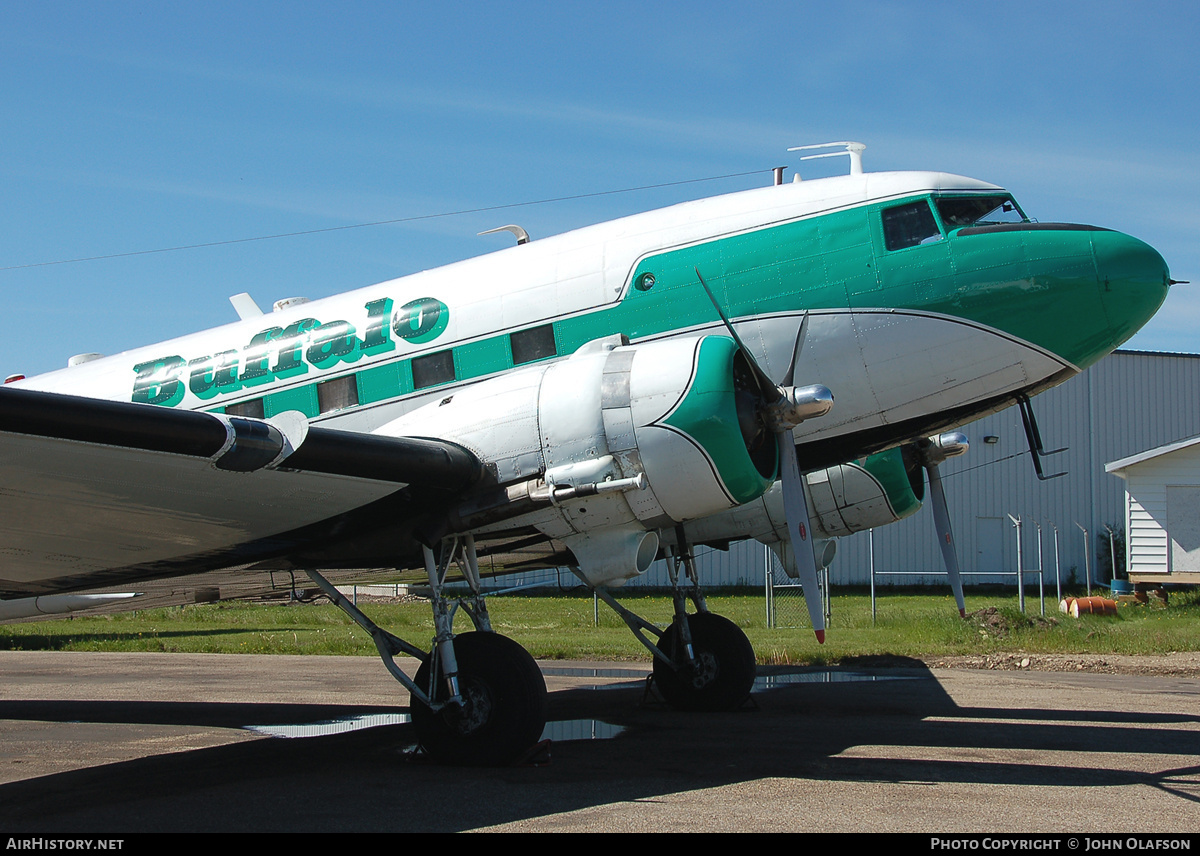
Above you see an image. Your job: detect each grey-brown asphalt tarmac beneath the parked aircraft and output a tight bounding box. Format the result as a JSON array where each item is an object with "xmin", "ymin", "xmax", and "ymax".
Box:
[{"xmin": 0, "ymin": 652, "xmax": 1200, "ymax": 834}]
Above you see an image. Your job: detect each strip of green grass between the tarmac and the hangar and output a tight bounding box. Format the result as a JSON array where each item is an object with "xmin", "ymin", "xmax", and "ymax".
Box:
[{"xmin": 0, "ymin": 591, "xmax": 1200, "ymax": 664}]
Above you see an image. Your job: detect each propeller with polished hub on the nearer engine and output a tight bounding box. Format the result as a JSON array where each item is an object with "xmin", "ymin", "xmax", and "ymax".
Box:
[{"xmin": 695, "ymin": 268, "xmax": 833, "ymax": 645}]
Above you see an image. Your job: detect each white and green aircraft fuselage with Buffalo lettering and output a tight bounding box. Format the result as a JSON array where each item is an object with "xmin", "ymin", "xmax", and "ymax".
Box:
[{"xmin": 20, "ymin": 172, "xmax": 1169, "ymax": 466}]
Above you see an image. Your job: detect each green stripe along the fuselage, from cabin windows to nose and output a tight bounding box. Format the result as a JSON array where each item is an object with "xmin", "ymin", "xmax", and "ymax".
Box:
[{"xmin": 211, "ymin": 194, "xmax": 1165, "ymax": 417}]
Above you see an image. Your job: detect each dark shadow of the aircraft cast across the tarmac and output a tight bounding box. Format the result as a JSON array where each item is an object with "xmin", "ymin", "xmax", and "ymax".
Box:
[{"xmin": 0, "ymin": 669, "xmax": 1200, "ymax": 832}]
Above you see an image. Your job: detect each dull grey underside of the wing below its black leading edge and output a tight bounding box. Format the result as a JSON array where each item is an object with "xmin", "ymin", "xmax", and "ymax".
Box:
[{"xmin": 0, "ymin": 433, "xmax": 402, "ymax": 591}]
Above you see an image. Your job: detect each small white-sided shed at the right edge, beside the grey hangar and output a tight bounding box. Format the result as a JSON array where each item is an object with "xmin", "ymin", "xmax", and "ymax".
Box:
[{"xmin": 1104, "ymin": 437, "xmax": 1200, "ymax": 583}]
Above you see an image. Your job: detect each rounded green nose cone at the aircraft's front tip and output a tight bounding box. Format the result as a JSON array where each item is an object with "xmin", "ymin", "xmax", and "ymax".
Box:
[{"xmin": 1092, "ymin": 232, "xmax": 1171, "ymax": 345}]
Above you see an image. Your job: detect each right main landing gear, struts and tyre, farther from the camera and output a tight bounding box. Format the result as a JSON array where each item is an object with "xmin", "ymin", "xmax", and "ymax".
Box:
[{"xmin": 581, "ymin": 527, "xmax": 757, "ymax": 711}]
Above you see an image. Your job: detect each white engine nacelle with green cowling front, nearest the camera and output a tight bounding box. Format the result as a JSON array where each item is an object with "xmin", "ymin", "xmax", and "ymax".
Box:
[{"xmin": 378, "ymin": 336, "xmax": 778, "ymax": 583}]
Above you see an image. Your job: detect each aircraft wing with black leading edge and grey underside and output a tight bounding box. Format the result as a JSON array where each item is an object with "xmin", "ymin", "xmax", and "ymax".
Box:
[{"xmin": 0, "ymin": 388, "xmax": 484, "ymax": 599}]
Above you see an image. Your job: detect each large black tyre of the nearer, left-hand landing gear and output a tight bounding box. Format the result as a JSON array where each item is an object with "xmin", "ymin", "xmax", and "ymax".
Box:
[{"xmin": 409, "ymin": 633, "xmax": 546, "ymax": 766}]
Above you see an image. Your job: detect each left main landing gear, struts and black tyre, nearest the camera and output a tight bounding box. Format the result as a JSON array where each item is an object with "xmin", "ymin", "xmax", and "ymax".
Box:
[{"xmin": 308, "ymin": 535, "xmax": 546, "ymax": 766}]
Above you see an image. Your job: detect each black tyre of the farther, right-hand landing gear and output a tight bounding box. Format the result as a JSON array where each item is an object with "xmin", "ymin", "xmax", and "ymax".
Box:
[{"xmin": 654, "ymin": 612, "xmax": 756, "ymax": 711}]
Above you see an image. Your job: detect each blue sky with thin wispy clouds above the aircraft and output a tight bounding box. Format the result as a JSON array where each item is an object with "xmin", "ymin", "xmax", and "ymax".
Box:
[{"xmin": 0, "ymin": 0, "xmax": 1200, "ymax": 376}]
